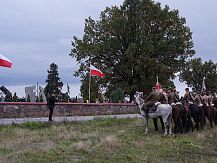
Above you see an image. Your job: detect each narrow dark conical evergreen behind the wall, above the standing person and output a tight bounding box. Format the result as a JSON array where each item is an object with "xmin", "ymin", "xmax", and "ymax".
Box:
[{"xmin": 44, "ymin": 63, "xmax": 63, "ymax": 97}]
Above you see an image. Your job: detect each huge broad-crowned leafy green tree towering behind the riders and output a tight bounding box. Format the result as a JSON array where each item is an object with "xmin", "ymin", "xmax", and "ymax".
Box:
[{"xmin": 70, "ymin": 0, "xmax": 194, "ymax": 100}]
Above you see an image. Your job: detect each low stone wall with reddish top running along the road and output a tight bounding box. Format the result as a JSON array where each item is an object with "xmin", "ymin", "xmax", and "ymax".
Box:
[{"xmin": 0, "ymin": 102, "xmax": 139, "ymax": 118}]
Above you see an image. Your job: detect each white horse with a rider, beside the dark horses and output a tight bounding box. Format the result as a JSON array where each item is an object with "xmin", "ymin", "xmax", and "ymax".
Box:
[{"xmin": 134, "ymin": 92, "xmax": 172, "ymax": 135}]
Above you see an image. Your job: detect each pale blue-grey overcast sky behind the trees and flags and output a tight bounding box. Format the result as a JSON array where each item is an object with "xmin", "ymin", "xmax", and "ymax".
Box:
[{"xmin": 0, "ymin": 0, "xmax": 217, "ymax": 97}]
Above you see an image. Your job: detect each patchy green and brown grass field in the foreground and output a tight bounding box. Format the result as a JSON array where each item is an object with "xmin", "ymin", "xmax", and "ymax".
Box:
[{"xmin": 0, "ymin": 119, "xmax": 217, "ymax": 163}]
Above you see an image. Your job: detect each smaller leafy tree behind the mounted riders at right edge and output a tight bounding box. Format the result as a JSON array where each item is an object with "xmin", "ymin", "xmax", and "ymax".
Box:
[{"xmin": 180, "ymin": 58, "xmax": 217, "ymax": 92}]
